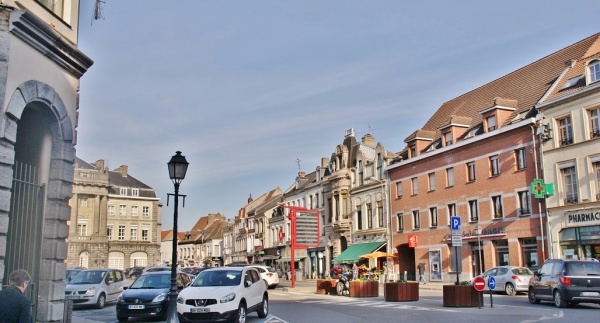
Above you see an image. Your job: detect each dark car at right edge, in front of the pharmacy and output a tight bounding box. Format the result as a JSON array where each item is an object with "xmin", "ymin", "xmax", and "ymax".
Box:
[{"xmin": 529, "ymin": 259, "xmax": 600, "ymax": 307}]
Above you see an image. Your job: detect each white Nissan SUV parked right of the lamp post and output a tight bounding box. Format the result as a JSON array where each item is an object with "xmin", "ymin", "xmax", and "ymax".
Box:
[{"xmin": 177, "ymin": 266, "xmax": 269, "ymax": 323}]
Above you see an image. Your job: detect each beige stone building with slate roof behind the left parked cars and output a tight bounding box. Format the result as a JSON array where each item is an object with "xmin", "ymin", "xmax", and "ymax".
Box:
[{"xmin": 67, "ymin": 158, "xmax": 161, "ymax": 269}]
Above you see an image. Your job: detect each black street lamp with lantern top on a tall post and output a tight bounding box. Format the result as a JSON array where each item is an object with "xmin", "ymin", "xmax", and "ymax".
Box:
[{"xmin": 167, "ymin": 151, "xmax": 189, "ymax": 322}]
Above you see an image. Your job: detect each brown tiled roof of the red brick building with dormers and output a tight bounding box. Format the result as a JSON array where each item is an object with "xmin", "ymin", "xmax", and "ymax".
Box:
[{"xmin": 405, "ymin": 33, "xmax": 600, "ymax": 141}]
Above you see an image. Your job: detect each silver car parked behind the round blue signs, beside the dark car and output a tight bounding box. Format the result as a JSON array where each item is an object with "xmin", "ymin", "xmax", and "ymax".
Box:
[{"xmin": 471, "ymin": 266, "xmax": 533, "ymax": 296}]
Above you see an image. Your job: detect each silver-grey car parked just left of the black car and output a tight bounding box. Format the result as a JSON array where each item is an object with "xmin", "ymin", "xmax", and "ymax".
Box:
[{"xmin": 65, "ymin": 268, "xmax": 129, "ymax": 308}]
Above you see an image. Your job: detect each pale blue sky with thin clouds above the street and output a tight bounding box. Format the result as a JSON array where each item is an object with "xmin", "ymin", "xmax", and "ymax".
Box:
[{"xmin": 76, "ymin": 0, "xmax": 600, "ymax": 231}]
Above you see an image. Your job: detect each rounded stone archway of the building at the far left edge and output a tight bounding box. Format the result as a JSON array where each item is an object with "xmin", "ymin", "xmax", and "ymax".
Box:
[{"xmin": 0, "ymin": 80, "xmax": 75, "ymax": 321}]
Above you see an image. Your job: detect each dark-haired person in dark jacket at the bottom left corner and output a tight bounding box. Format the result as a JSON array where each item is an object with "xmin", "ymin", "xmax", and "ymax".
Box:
[{"xmin": 0, "ymin": 269, "xmax": 33, "ymax": 323}]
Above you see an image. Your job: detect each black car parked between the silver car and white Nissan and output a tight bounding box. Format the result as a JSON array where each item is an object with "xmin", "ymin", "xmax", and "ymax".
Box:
[{"xmin": 116, "ymin": 271, "xmax": 190, "ymax": 322}]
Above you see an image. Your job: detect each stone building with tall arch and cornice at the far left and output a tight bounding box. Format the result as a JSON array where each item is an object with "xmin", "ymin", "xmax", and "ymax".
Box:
[{"xmin": 0, "ymin": 0, "xmax": 93, "ymax": 322}]
